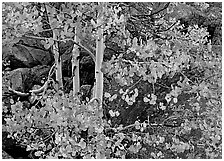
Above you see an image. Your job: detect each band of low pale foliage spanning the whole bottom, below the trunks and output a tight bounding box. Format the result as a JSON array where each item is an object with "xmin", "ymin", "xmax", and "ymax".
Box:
[{"xmin": 5, "ymin": 74, "xmax": 222, "ymax": 158}]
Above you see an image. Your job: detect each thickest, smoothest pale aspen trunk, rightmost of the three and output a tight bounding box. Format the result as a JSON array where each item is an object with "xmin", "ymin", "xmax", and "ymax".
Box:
[{"xmin": 94, "ymin": 17, "xmax": 104, "ymax": 105}]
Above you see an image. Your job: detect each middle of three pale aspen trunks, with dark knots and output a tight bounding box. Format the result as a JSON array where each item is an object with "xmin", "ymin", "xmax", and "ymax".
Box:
[{"xmin": 72, "ymin": 27, "xmax": 80, "ymax": 96}]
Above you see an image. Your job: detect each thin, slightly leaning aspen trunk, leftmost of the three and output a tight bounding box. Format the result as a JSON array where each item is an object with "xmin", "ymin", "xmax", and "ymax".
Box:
[{"xmin": 53, "ymin": 32, "xmax": 63, "ymax": 89}]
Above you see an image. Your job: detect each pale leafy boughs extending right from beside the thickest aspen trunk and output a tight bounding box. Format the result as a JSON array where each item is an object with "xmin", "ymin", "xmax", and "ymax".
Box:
[{"xmin": 103, "ymin": 23, "xmax": 212, "ymax": 102}]
